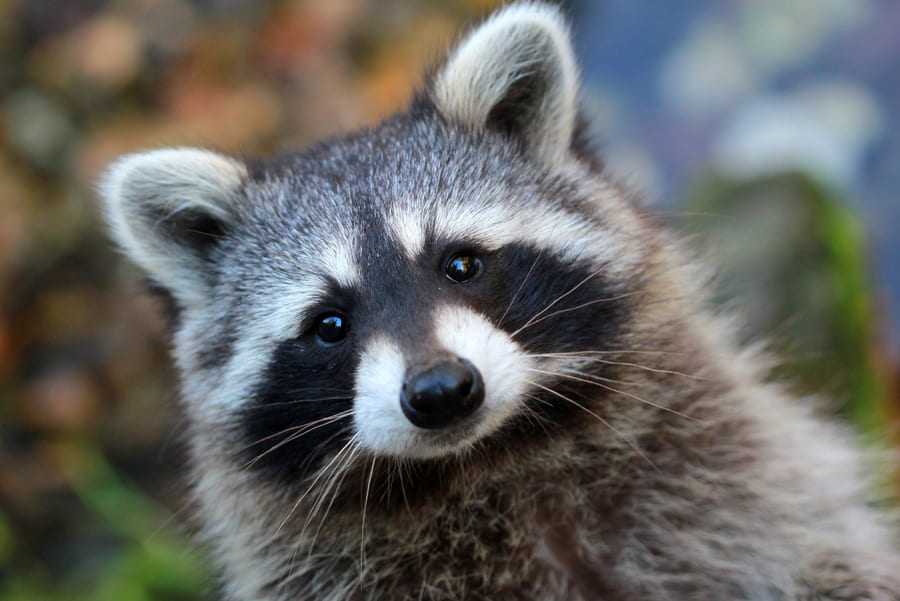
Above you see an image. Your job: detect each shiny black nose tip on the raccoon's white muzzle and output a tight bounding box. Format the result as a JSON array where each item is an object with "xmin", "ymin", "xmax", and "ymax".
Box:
[{"xmin": 400, "ymin": 359, "xmax": 484, "ymax": 429}]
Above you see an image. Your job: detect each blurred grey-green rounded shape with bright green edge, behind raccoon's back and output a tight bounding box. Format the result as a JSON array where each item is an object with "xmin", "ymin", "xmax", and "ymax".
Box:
[{"xmin": 687, "ymin": 173, "xmax": 889, "ymax": 440}]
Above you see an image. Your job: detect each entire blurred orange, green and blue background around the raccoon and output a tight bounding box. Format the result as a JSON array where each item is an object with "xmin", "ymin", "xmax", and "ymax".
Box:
[{"xmin": 0, "ymin": 0, "xmax": 900, "ymax": 601}]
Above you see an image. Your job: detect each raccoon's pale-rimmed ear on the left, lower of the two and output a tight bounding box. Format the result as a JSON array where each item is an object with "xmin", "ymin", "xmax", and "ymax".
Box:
[{"xmin": 99, "ymin": 148, "xmax": 247, "ymax": 305}]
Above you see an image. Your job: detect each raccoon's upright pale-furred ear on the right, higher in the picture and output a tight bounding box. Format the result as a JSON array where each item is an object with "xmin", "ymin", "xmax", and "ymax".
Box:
[{"xmin": 432, "ymin": 2, "xmax": 578, "ymax": 166}]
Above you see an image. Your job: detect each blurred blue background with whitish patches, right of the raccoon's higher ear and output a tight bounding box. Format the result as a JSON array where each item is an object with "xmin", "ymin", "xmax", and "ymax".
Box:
[{"xmin": 571, "ymin": 0, "xmax": 900, "ymax": 340}]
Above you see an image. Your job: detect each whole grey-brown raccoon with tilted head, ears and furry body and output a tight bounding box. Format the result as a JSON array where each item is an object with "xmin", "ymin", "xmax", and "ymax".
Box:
[{"xmin": 100, "ymin": 2, "xmax": 900, "ymax": 601}]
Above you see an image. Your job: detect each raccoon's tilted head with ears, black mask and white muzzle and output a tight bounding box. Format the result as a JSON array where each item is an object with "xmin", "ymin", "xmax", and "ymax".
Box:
[{"xmin": 101, "ymin": 4, "xmax": 642, "ymax": 478}]
